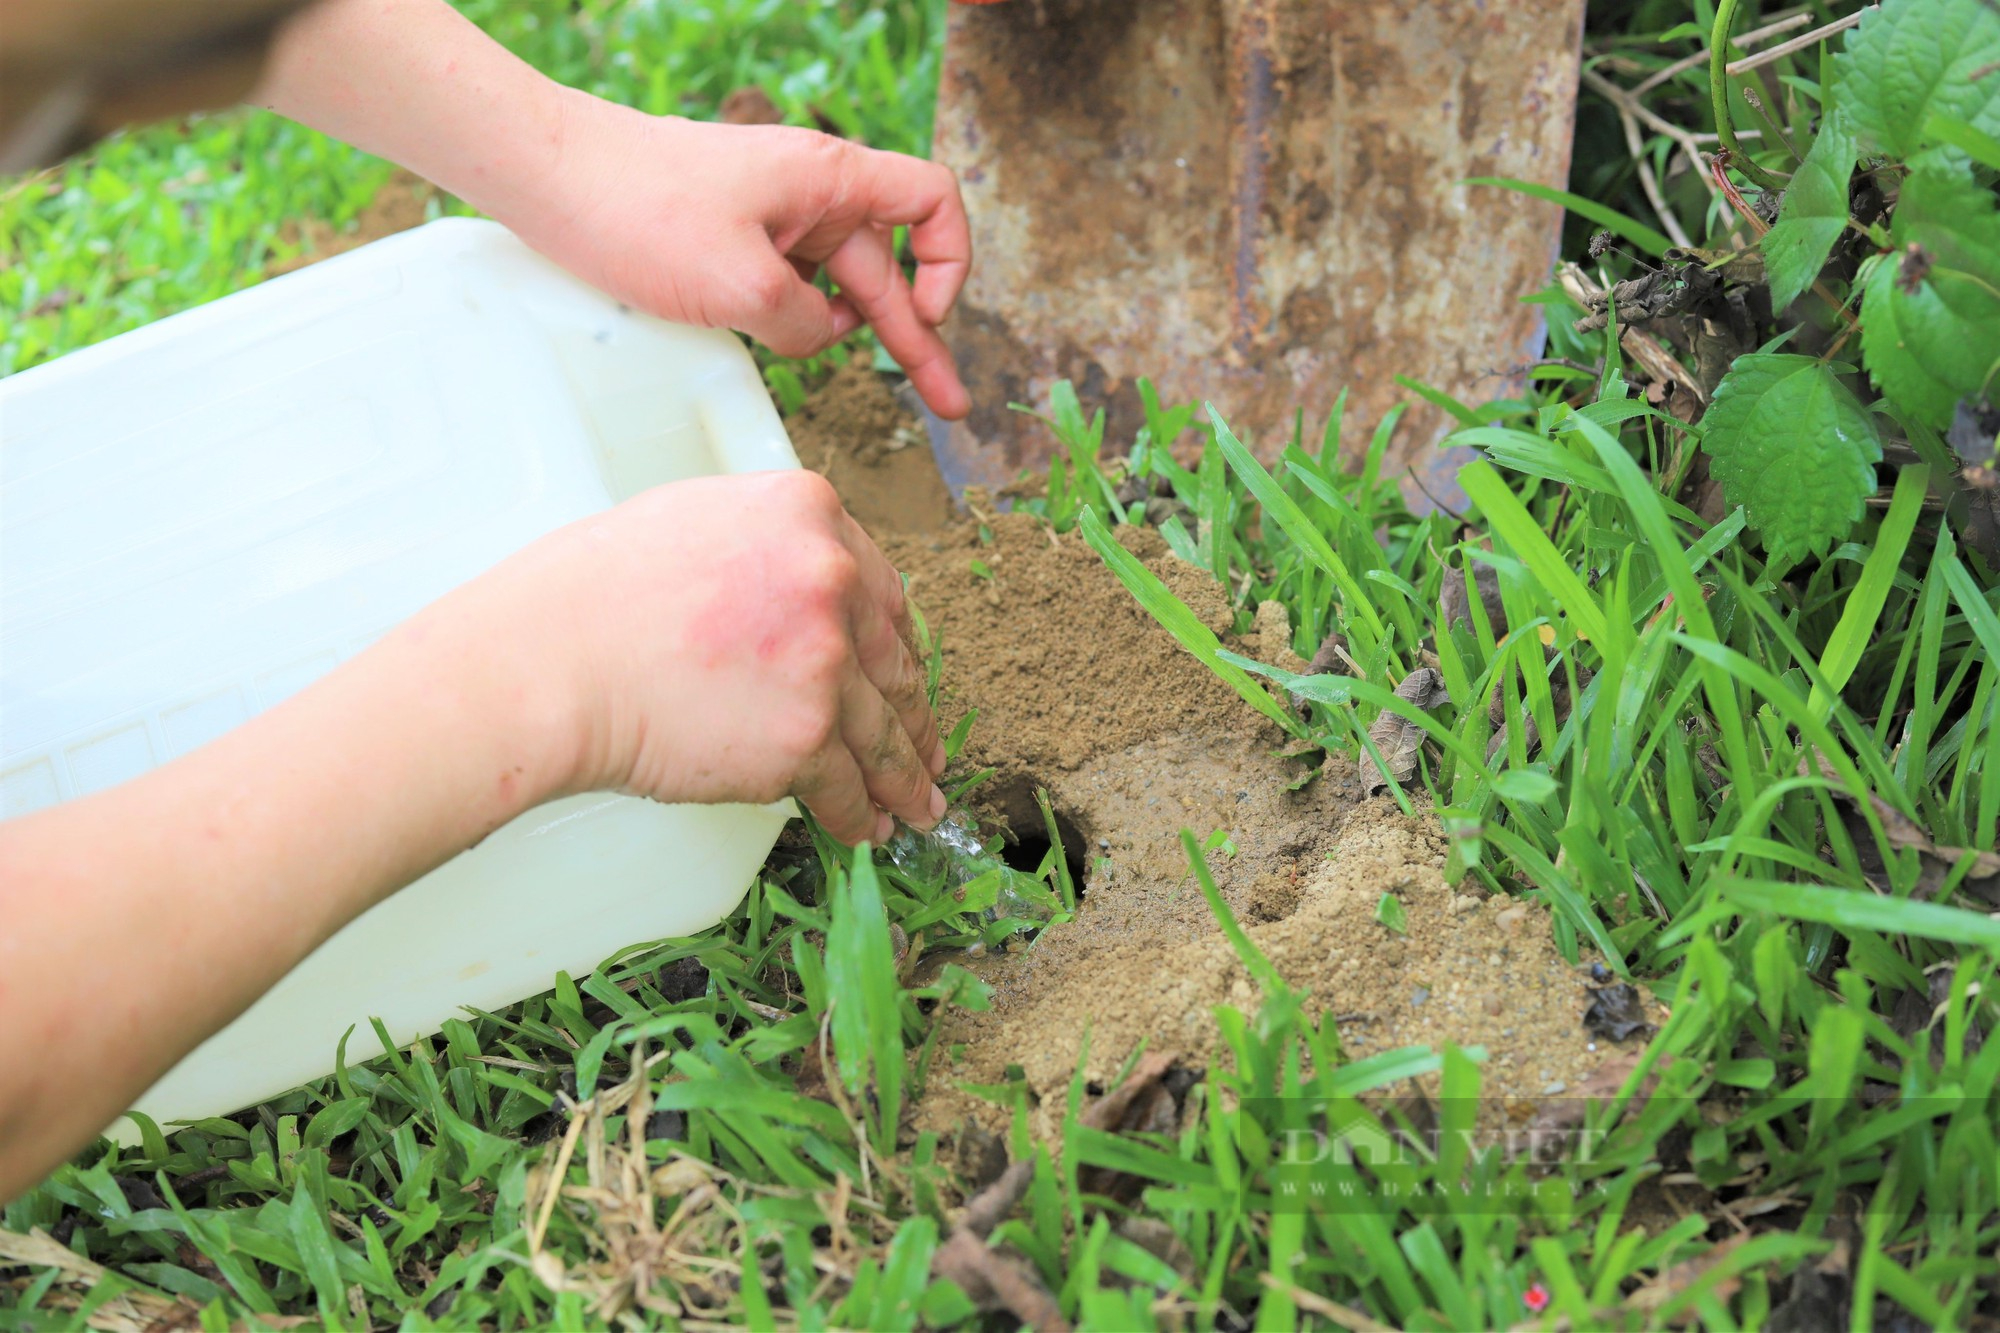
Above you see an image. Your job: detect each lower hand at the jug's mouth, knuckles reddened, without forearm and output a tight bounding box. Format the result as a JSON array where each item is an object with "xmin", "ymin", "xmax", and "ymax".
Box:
[{"xmin": 488, "ymin": 472, "xmax": 944, "ymax": 843}]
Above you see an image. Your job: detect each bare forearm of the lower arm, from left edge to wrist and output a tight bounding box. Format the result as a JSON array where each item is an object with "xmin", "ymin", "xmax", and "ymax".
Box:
[{"xmin": 0, "ymin": 584, "xmax": 568, "ymax": 1201}]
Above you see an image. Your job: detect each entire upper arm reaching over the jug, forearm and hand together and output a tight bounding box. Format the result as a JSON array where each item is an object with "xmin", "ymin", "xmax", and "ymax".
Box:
[{"xmin": 254, "ymin": 0, "xmax": 972, "ymax": 420}]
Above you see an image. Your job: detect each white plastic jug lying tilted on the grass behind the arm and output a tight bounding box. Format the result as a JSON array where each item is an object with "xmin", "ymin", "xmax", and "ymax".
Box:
[{"xmin": 0, "ymin": 218, "xmax": 798, "ymax": 1133}]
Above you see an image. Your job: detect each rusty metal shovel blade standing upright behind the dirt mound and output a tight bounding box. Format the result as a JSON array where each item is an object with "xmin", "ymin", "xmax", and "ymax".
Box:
[{"xmin": 934, "ymin": 0, "xmax": 1584, "ymax": 508}]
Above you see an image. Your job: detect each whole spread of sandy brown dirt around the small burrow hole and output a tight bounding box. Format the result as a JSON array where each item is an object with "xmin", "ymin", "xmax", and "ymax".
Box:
[{"xmin": 812, "ymin": 382, "xmax": 1606, "ymax": 1139}]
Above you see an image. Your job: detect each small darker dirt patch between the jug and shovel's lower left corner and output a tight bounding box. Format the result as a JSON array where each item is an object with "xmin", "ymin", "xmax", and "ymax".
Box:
[{"xmin": 784, "ymin": 364, "xmax": 952, "ymax": 540}]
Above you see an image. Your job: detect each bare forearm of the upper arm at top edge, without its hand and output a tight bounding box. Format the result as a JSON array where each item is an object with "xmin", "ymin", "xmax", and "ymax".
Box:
[{"xmin": 250, "ymin": 0, "xmax": 570, "ymax": 220}]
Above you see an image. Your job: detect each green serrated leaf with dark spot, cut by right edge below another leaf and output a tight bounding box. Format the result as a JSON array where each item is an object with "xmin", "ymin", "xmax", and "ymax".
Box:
[{"xmin": 1862, "ymin": 170, "xmax": 2000, "ymax": 428}]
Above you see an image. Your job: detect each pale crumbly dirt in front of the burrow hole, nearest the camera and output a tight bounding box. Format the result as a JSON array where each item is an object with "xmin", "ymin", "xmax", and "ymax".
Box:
[{"xmin": 918, "ymin": 799, "xmax": 1606, "ymax": 1141}]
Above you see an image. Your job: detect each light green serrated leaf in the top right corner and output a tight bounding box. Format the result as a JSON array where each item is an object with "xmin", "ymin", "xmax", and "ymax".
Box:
[{"xmin": 1834, "ymin": 0, "xmax": 2000, "ymax": 164}]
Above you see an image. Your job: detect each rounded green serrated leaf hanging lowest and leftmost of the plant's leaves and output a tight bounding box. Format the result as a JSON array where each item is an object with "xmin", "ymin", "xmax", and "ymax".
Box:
[{"xmin": 1702, "ymin": 352, "xmax": 1882, "ymax": 556}]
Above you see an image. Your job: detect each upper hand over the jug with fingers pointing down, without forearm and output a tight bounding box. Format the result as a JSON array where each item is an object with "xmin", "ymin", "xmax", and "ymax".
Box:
[{"xmin": 496, "ymin": 88, "xmax": 972, "ymax": 420}]
